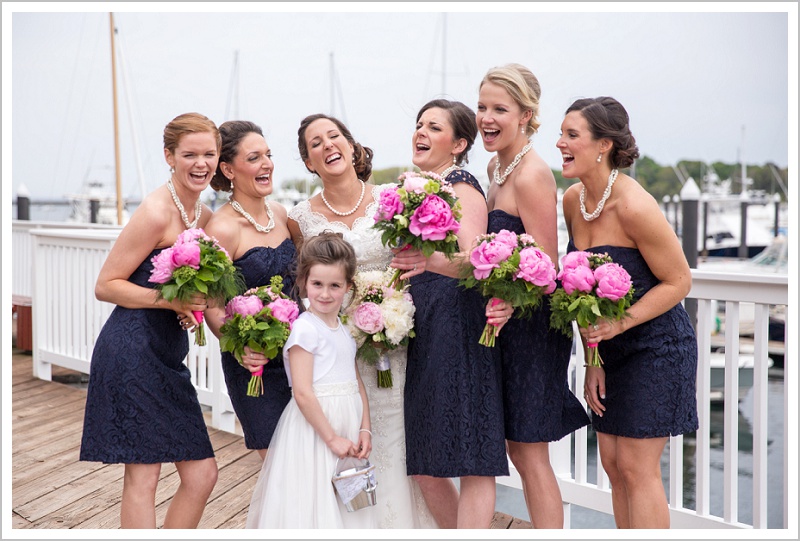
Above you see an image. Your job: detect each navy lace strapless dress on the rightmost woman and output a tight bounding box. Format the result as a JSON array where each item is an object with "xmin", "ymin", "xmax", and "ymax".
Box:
[{"xmin": 567, "ymin": 239, "xmax": 699, "ymax": 438}]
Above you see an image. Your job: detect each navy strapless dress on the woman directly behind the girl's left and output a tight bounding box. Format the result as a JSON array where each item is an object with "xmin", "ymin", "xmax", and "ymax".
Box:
[{"xmin": 222, "ymin": 239, "xmax": 295, "ymax": 449}]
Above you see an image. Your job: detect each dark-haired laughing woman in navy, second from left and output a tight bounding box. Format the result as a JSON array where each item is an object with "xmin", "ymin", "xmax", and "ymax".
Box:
[{"xmin": 206, "ymin": 120, "xmax": 295, "ymax": 459}]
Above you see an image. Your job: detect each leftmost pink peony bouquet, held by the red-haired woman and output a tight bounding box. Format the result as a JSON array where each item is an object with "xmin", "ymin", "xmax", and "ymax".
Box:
[{"xmin": 150, "ymin": 228, "xmax": 244, "ymax": 346}]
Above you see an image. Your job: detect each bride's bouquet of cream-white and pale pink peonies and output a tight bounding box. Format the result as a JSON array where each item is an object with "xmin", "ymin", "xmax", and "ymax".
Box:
[{"xmin": 343, "ymin": 269, "xmax": 415, "ymax": 388}]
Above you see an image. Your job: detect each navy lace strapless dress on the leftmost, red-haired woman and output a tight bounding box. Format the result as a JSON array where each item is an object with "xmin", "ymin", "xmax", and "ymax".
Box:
[{"xmin": 80, "ymin": 249, "xmax": 214, "ymax": 464}]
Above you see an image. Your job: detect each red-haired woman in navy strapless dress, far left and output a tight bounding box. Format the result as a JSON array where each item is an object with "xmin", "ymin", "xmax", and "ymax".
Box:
[{"xmin": 80, "ymin": 113, "xmax": 220, "ymax": 529}]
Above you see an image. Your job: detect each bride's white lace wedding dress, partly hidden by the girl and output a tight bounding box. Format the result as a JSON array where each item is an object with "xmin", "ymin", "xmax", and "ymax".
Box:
[{"xmin": 289, "ymin": 184, "xmax": 438, "ymax": 528}]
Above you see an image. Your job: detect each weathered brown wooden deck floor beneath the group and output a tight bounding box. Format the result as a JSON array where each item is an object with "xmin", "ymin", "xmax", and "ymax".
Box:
[{"xmin": 6, "ymin": 350, "xmax": 530, "ymax": 529}]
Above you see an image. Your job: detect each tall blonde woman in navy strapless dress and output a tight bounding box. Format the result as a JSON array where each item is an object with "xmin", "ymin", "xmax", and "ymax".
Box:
[{"xmin": 477, "ymin": 64, "xmax": 589, "ymax": 528}]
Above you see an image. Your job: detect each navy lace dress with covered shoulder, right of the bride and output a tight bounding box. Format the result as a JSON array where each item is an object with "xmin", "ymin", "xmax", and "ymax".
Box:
[{"xmin": 405, "ymin": 171, "xmax": 508, "ymax": 477}]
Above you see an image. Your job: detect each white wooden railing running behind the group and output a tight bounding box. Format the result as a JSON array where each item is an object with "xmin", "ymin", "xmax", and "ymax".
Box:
[{"xmin": 12, "ymin": 222, "xmax": 796, "ymax": 528}]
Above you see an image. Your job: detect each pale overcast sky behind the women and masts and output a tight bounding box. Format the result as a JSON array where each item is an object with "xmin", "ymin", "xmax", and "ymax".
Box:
[{"xmin": 2, "ymin": 2, "xmax": 797, "ymax": 202}]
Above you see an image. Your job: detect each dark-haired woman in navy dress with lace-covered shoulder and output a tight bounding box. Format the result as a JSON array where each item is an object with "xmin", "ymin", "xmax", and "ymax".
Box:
[{"xmin": 404, "ymin": 100, "xmax": 511, "ymax": 528}]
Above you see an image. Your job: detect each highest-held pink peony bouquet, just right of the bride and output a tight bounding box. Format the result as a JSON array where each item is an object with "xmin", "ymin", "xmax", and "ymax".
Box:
[{"xmin": 373, "ymin": 171, "xmax": 461, "ymax": 289}]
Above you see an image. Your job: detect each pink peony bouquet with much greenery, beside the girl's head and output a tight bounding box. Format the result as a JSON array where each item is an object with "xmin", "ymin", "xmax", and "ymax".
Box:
[{"xmin": 219, "ymin": 276, "xmax": 300, "ymax": 396}]
